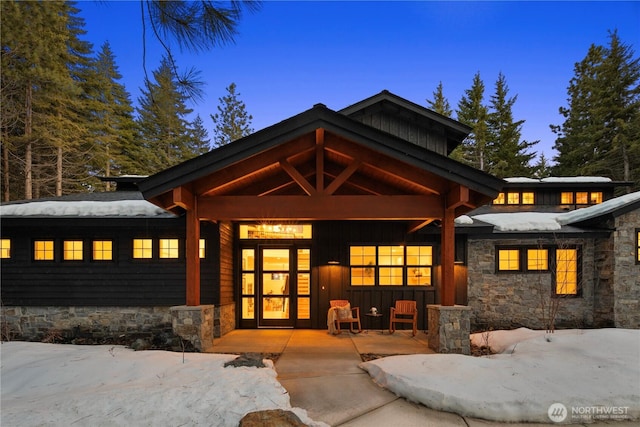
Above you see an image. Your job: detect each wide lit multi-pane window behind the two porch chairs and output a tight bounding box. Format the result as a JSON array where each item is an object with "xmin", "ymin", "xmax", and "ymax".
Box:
[{"xmin": 349, "ymin": 245, "xmax": 433, "ymax": 286}]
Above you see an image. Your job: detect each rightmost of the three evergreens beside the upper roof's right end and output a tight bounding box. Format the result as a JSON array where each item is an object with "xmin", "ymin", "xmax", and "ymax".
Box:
[{"xmin": 487, "ymin": 73, "xmax": 538, "ymax": 178}]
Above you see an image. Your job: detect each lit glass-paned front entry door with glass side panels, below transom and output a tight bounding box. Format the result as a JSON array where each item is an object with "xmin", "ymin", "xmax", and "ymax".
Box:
[{"xmin": 241, "ymin": 245, "xmax": 311, "ymax": 327}]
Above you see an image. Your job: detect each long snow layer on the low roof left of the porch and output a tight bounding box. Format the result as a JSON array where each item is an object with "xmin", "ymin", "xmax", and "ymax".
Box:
[{"xmin": 0, "ymin": 200, "xmax": 175, "ymax": 217}]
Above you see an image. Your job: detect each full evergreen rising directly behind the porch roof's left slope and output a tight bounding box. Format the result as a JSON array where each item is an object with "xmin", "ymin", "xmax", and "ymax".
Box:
[{"xmin": 132, "ymin": 58, "xmax": 198, "ymax": 174}]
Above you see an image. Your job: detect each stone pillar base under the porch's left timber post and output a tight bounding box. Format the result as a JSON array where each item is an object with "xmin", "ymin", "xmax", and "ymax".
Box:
[{"xmin": 170, "ymin": 305, "xmax": 214, "ymax": 352}]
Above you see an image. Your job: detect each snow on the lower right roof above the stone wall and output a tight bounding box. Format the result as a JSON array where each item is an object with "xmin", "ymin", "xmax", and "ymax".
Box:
[{"xmin": 464, "ymin": 191, "xmax": 640, "ymax": 231}]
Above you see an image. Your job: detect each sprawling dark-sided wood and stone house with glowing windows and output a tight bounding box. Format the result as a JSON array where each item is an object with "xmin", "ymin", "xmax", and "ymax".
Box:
[{"xmin": 0, "ymin": 91, "xmax": 640, "ymax": 352}]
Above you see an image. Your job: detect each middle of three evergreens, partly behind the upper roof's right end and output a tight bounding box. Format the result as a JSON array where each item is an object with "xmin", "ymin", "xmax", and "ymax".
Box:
[{"xmin": 451, "ymin": 73, "xmax": 489, "ymax": 171}]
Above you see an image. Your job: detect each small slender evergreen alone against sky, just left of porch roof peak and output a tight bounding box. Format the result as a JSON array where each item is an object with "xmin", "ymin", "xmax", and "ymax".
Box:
[{"xmin": 211, "ymin": 83, "xmax": 253, "ymax": 147}]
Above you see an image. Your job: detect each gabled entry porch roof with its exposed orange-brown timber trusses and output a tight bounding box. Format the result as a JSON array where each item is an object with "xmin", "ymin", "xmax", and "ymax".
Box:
[{"xmin": 141, "ymin": 106, "xmax": 501, "ymax": 227}]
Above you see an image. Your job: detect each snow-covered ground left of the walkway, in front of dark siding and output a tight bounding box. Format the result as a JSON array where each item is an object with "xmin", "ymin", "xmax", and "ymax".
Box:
[{"xmin": 0, "ymin": 342, "xmax": 325, "ymax": 427}]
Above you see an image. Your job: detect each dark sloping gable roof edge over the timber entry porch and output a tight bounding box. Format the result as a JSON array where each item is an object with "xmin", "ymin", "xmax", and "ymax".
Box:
[{"xmin": 139, "ymin": 99, "xmax": 504, "ymax": 202}]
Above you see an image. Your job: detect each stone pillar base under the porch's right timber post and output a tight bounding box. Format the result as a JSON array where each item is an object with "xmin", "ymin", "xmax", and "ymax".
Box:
[{"xmin": 427, "ymin": 304, "xmax": 471, "ymax": 355}]
